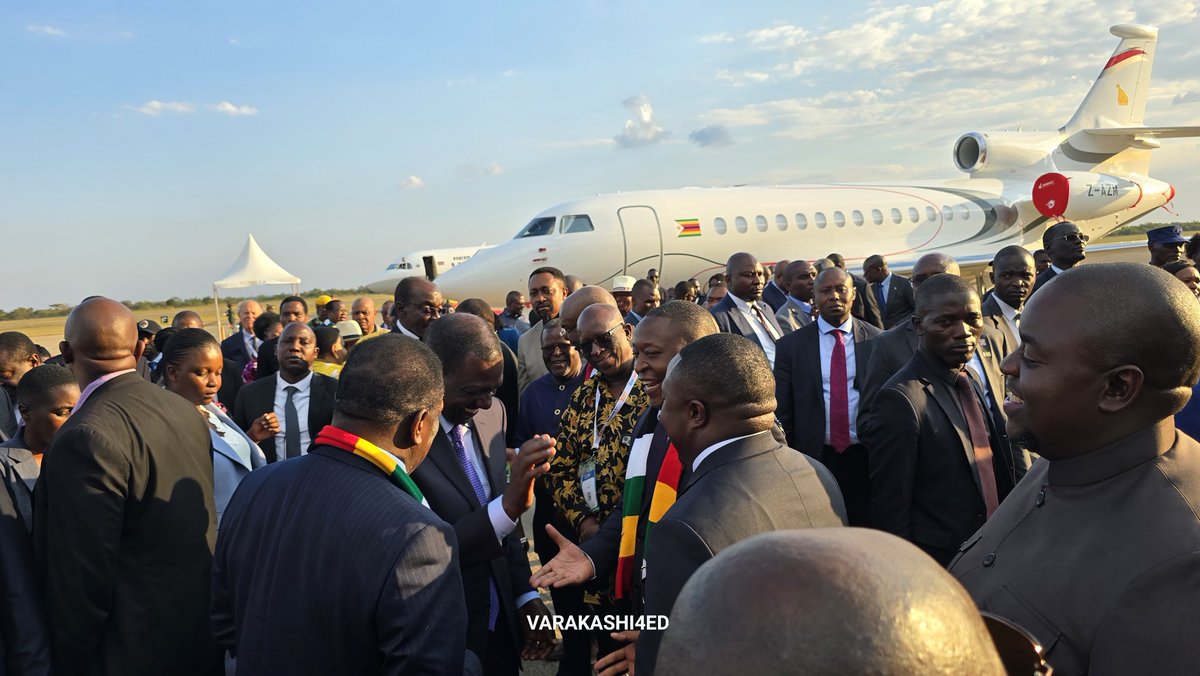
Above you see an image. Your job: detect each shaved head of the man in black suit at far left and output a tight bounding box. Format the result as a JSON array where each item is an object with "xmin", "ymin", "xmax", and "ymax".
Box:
[{"xmin": 60, "ymin": 297, "xmax": 140, "ymax": 388}]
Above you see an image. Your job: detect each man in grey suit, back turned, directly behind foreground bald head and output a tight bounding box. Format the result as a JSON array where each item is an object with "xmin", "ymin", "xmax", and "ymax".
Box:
[{"xmin": 636, "ymin": 334, "xmax": 846, "ymax": 676}]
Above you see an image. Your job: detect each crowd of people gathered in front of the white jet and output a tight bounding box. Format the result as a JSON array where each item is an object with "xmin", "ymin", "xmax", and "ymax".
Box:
[{"xmin": 0, "ymin": 222, "xmax": 1200, "ymax": 676}]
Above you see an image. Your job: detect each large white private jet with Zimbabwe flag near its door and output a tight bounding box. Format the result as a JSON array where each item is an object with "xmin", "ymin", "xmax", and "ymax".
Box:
[{"xmin": 437, "ymin": 24, "xmax": 1200, "ymax": 305}]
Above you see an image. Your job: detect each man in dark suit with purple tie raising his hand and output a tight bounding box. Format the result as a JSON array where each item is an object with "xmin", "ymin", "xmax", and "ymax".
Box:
[{"xmin": 413, "ymin": 313, "xmax": 554, "ymax": 675}]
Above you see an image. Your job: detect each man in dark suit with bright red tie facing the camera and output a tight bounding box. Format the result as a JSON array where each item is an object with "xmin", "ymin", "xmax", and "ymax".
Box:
[{"xmin": 775, "ymin": 268, "xmax": 881, "ymax": 527}]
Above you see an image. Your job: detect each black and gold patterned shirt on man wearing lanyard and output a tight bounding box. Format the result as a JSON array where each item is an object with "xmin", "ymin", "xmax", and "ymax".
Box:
[{"xmin": 550, "ymin": 372, "xmax": 650, "ymax": 528}]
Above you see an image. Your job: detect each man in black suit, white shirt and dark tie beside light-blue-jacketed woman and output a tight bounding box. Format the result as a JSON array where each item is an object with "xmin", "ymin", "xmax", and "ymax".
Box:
[{"xmin": 232, "ymin": 322, "xmax": 337, "ymax": 462}]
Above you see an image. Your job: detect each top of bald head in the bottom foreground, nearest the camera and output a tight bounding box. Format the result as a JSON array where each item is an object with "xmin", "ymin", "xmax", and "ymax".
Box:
[{"xmin": 658, "ymin": 528, "xmax": 1003, "ymax": 676}]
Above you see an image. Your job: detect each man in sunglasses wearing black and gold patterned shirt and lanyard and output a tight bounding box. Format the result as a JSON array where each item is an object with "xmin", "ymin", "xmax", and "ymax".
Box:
[{"xmin": 550, "ymin": 304, "xmax": 650, "ymax": 654}]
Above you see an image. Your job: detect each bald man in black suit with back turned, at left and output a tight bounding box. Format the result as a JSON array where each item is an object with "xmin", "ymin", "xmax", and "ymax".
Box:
[{"xmin": 34, "ymin": 298, "xmax": 220, "ymax": 674}]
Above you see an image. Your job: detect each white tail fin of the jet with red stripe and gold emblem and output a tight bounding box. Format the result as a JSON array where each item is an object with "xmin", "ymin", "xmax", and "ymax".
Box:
[{"xmin": 1063, "ymin": 24, "xmax": 1156, "ymax": 136}]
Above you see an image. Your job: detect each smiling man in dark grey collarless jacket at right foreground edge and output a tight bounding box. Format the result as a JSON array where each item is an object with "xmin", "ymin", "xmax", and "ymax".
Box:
[{"xmin": 950, "ymin": 263, "xmax": 1200, "ymax": 675}]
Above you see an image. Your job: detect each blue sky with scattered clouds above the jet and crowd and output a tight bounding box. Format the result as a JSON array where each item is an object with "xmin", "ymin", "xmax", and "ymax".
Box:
[{"xmin": 0, "ymin": 0, "xmax": 1200, "ymax": 309}]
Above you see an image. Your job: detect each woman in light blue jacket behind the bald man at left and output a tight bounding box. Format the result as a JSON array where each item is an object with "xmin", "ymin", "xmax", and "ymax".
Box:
[{"xmin": 161, "ymin": 331, "xmax": 266, "ymax": 528}]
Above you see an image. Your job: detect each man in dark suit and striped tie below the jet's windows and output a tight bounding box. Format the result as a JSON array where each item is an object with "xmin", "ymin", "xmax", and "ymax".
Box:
[{"xmin": 710, "ymin": 253, "xmax": 784, "ymax": 364}]
